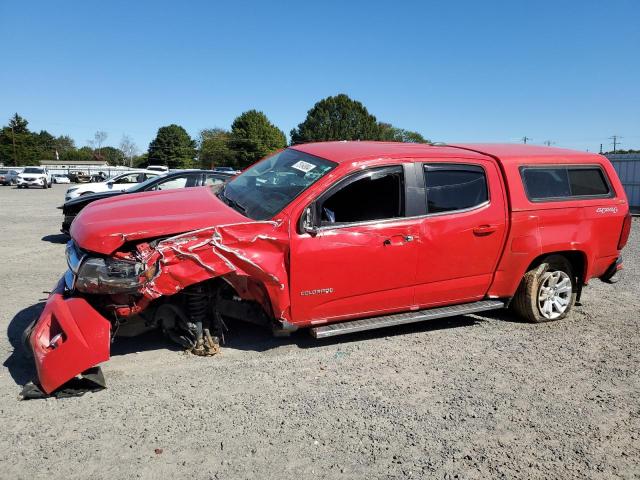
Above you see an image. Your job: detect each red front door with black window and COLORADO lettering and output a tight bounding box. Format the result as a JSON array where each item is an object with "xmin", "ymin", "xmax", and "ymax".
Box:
[{"xmin": 290, "ymin": 165, "xmax": 420, "ymax": 324}]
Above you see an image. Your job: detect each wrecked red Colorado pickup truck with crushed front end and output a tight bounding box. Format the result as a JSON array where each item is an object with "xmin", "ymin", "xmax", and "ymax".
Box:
[{"xmin": 25, "ymin": 142, "xmax": 631, "ymax": 393}]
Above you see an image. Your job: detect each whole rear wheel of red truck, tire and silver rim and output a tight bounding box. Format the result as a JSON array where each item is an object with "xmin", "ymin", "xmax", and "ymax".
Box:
[{"xmin": 511, "ymin": 255, "xmax": 577, "ymax": 323}]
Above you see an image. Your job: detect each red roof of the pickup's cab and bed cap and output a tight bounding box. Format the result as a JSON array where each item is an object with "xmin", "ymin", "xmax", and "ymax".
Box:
[{"xmin": 293, "ymin": 141, "xmax": 594, "ymax": 163}]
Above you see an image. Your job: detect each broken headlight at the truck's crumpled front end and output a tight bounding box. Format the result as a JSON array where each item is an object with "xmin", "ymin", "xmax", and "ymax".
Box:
[{"xmin": 75, "ymin": 257, "xmax": 155, "ymax": 295}]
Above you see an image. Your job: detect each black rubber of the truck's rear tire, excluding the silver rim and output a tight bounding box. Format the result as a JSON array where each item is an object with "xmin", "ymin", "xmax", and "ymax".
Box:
[{"xmin": 511, "ymin": 255, "xmax": 577, "ymax": 323}]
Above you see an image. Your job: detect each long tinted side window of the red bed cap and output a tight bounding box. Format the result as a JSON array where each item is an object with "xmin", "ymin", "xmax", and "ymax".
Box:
[{"xmin": 520, "ymin": 166, "xmax": 610, "ymax": 201}]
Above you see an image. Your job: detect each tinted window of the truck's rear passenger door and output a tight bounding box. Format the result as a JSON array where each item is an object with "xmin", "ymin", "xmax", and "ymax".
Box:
[{"xmin": 424, "ymin": 163, "xmax": 489, "ymax": 214}]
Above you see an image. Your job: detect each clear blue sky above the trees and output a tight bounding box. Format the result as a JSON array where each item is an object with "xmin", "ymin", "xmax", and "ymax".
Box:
[{"xmin": 0, "ymin": 0, "xmax": 640, "ymax": 152}]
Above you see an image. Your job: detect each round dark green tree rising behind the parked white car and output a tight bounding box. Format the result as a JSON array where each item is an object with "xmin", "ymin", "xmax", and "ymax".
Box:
[{"xmin": 148, "ymin": 124, "xmax": 196, "ymax": 168}]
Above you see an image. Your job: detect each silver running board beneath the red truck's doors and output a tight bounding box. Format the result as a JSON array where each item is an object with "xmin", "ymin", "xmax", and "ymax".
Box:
[{"xmin": 311, "ymin": 300, "xmax": 505, "ymax": 338}]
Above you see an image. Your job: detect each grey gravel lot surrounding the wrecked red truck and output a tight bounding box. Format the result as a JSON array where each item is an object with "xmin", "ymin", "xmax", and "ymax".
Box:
[{"xmin": 0, "ymin": 185, "xmax": 640, "ymax": 479}]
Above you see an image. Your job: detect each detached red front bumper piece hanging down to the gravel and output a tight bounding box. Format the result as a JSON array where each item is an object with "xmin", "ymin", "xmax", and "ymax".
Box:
[{"xmin": 28, "ymin": 278, "xmax": 111, "ymax": 394}]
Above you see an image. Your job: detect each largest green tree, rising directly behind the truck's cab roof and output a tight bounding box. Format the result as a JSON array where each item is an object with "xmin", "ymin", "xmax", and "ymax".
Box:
[{"xmin": 291, "ymin": 93, "xmax": 380, "ymax": 144}]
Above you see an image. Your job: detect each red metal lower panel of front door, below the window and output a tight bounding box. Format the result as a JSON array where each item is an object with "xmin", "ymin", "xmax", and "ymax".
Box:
[{"xmin": 291, "ymin": 219, "xmax": 419, "ymax": 324}]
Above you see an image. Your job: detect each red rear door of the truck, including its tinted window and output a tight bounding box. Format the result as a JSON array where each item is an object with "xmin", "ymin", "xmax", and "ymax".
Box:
[{"xmin": 415, "ymin": 159, "xmax": 507, "ymax": 308}]
